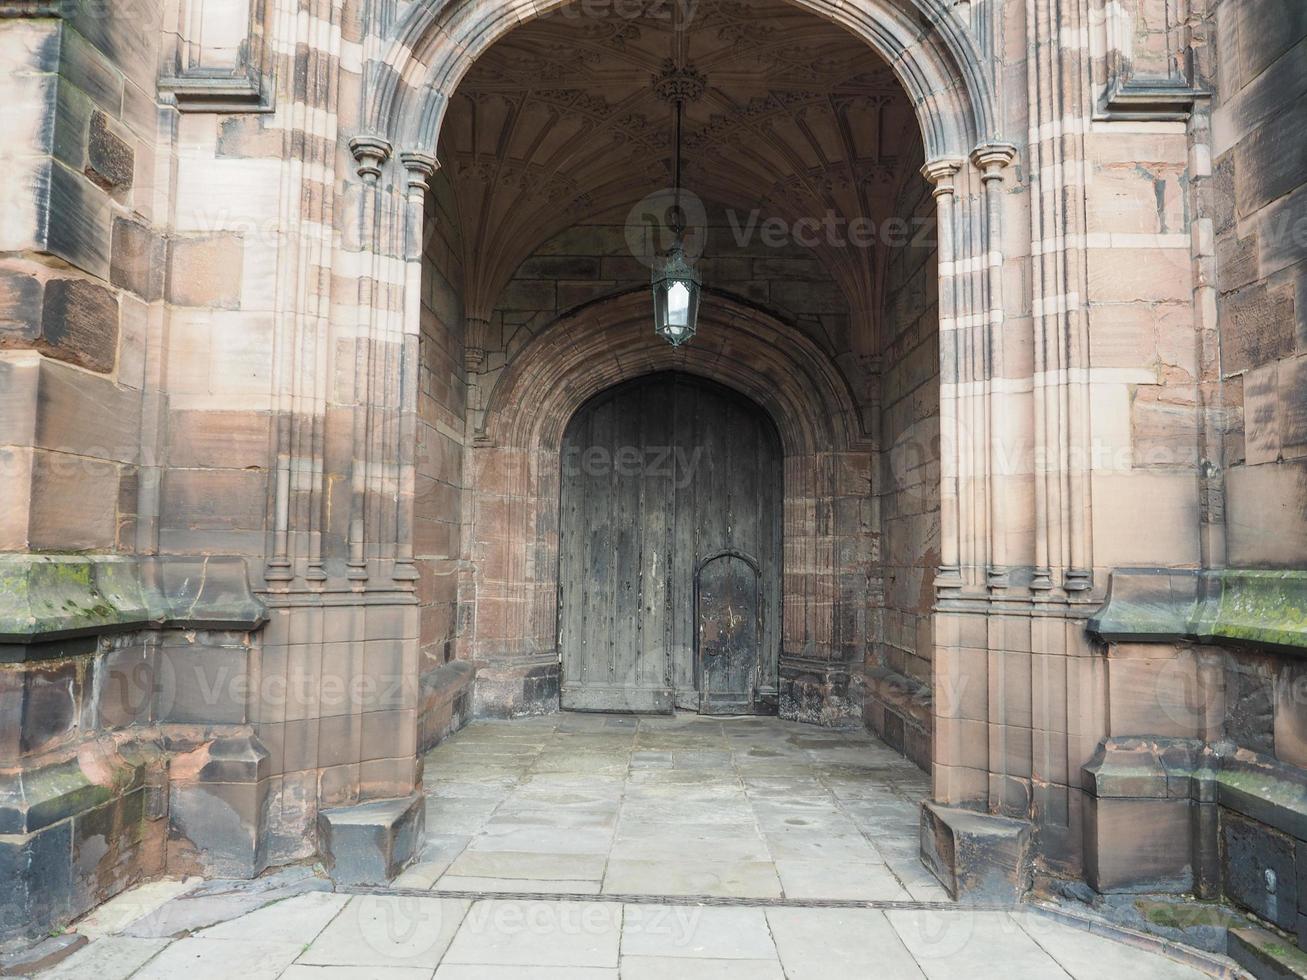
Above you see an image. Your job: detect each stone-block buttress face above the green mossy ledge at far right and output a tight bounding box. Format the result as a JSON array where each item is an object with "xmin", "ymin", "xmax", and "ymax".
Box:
[{"xmin": 1212, "ymin": 0, "xmax": 1307, "ymax": 567}]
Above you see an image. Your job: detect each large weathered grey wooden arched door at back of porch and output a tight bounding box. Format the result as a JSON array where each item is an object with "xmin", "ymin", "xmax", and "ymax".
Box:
[{"xmin": 558, "ymin": 372, "xmax": 783, "ymax": 712}]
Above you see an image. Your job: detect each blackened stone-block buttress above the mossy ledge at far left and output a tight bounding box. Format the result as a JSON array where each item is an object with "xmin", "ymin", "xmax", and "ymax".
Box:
[{"xmin": 0, "ymin": 3, "xmax": 169, "ymax": 551}]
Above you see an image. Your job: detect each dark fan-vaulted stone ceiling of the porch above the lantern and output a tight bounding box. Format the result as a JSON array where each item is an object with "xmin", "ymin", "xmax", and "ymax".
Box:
[{"xmin": 440, "ymin": 0, "xmax": 920, "ymax": 342}]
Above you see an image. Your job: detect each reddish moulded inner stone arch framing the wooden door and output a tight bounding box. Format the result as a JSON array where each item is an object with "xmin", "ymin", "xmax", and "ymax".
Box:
[{"xmin": 468, "ymin": 293, "xmax": 874, "ymax": 721}]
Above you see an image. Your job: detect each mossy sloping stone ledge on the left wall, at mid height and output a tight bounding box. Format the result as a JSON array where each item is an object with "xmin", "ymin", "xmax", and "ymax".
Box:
[{"xmin": 0, "ymin": 554, "xmax": 268, "ymax": 664}]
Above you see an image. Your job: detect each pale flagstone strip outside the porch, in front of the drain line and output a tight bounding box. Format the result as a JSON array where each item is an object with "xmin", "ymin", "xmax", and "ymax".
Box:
[{"xmin": 41, "ymin": 891, "xmax": 1223, "ymax": 980}]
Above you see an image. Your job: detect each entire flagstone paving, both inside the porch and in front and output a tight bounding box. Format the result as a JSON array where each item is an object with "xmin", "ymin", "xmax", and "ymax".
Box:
[{"xmin": 33, "ymin": 715, "xmax": 1233, "ymax": 980}]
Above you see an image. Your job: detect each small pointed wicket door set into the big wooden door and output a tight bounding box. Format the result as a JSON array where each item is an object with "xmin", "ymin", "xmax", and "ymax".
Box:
[{"xmin": 695, "ymin": 553, "xmax": 762, "ymax": 715}]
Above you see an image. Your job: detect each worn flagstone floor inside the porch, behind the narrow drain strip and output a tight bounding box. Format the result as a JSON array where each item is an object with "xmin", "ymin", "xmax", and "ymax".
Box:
[{"xmin": 407, "ymin": 713, "xmax": 948, "ymax": 902}]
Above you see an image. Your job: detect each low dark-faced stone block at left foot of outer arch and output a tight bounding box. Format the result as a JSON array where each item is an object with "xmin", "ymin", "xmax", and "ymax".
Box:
[{"xmin": 318, "ymin": 793, "xmax": 426, "ymax": 886}]
